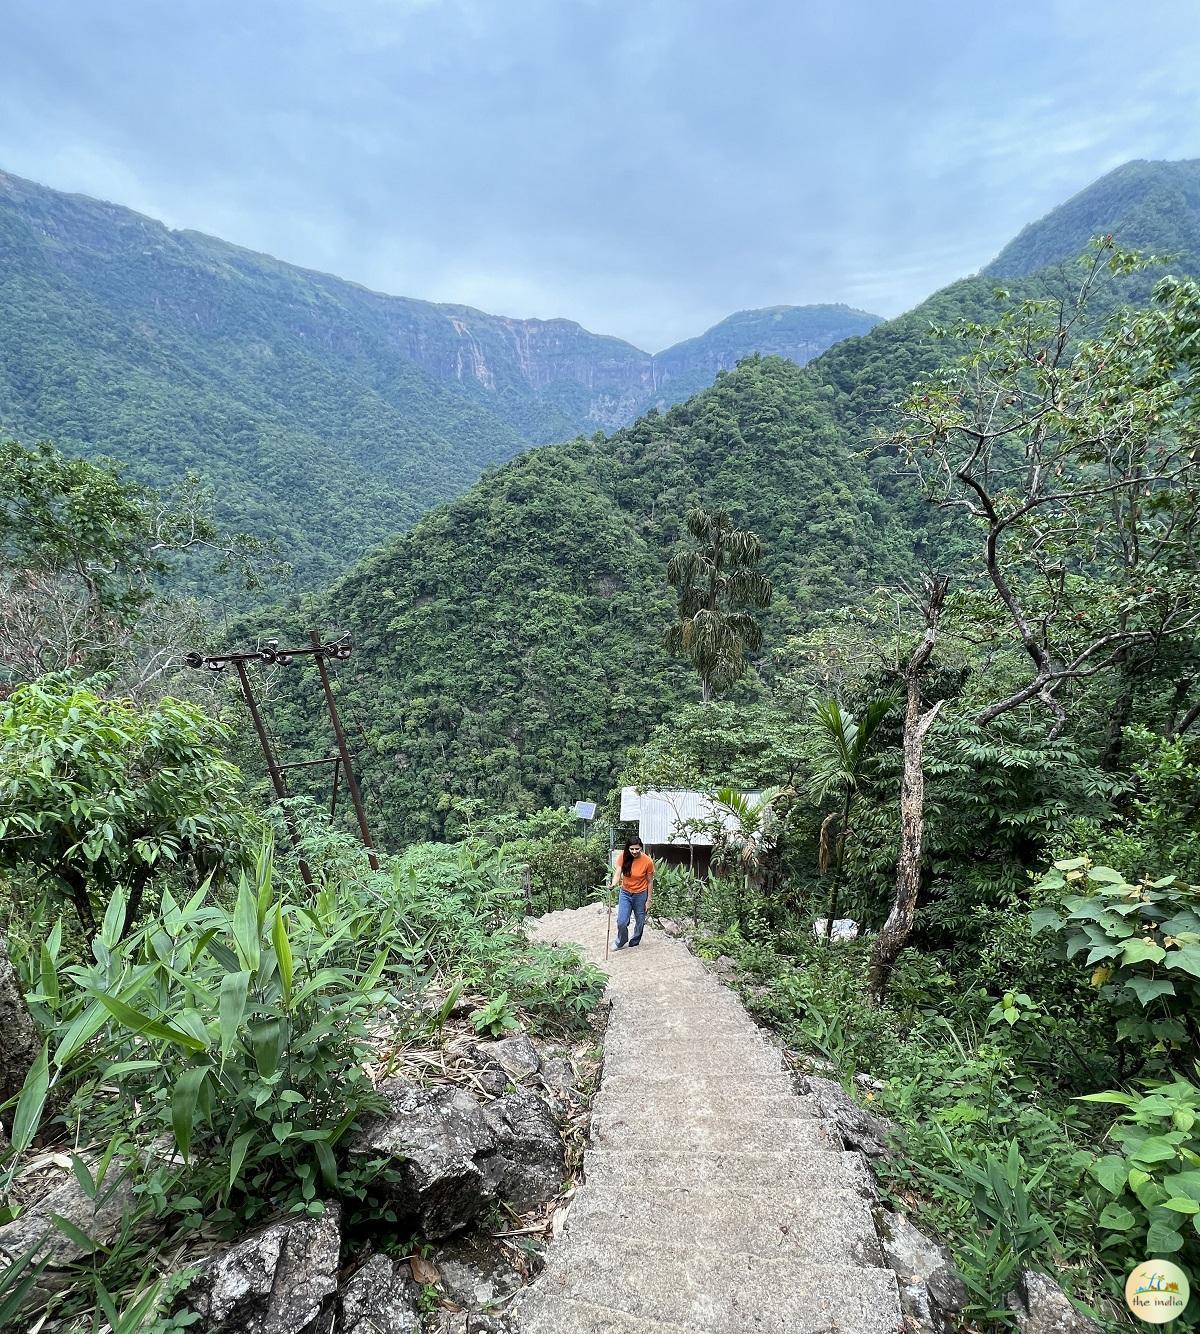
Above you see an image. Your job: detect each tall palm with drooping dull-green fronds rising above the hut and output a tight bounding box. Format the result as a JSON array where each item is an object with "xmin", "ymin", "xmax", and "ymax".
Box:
[{"xmin": 667, "ymin": 510, "xmax": 771, "ymax": 703}]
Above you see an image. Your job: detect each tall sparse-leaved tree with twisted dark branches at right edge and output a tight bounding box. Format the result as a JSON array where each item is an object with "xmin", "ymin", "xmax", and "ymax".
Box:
[{"xmin": 893, "ymin": 248, "xmax": 1200, "ymax": 738}]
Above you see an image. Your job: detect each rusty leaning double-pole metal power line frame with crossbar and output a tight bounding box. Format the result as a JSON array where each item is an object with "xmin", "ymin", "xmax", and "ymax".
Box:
[{"xmin": 184, "ymin": 630, "xmax": 379, "ymax": 887}]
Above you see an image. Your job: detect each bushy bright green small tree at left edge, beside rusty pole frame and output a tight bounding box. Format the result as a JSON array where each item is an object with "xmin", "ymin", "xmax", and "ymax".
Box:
[{"xmin": 0, "ymin": 676, "xmax": 249, "ymax": 932}]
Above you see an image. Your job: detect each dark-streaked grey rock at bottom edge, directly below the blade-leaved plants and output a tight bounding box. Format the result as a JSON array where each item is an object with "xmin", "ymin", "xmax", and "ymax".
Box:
[{"xmin": 184, "ymin": 1203, "xmax": 341, "ymax": 1334}]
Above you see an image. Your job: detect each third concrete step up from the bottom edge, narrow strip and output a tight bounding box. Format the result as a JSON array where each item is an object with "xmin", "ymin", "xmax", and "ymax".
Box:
[{"xmin": 584, "ymin": 1145, "xmax": 875, "ymax": 1199}]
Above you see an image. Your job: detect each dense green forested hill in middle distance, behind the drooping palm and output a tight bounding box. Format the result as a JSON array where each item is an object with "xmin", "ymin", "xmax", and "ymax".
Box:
[{"xmin": 255, "ymin": 158, "xmax": 1200, "ymax": 838}]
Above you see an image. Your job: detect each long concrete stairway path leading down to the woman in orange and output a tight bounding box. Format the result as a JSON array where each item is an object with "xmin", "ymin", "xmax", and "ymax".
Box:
[{"xmin": 511, "ymin": 907, "xmax": 904, "ymax": 1334}]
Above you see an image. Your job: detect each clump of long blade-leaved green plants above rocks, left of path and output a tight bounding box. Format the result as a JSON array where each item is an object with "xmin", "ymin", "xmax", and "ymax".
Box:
[{"xmin": 19, "ymin": 847, "xmax": 395, "ymax": 1222}]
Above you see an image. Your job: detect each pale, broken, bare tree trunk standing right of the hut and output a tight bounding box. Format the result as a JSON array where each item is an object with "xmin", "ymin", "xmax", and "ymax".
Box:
[{"xmin": 867, "ymin": 578, "xmax": 947, "ymax": 1005}]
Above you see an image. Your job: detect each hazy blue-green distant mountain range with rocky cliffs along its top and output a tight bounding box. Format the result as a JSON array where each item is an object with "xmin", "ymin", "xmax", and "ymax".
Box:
[{"xmin": 0, "ymin": 173, "xmax": 875, "ymax": 587}]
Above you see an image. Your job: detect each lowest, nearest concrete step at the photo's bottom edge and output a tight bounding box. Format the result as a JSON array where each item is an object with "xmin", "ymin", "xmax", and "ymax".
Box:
[{"xmin": 537, "ymin": 1235, "xmax": 904, "ymax": 1334}]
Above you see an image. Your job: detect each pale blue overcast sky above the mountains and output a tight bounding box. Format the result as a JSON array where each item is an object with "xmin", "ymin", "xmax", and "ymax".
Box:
[{"xmin": 0, "ymin": 0, "xmax": 1200, "ymax": 351}]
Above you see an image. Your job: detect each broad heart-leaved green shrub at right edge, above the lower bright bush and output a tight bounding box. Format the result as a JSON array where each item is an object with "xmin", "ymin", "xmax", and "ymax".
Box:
[{"xmin": 1031, "ymin": 856, "xmax": 1200, "ymax": 1069}]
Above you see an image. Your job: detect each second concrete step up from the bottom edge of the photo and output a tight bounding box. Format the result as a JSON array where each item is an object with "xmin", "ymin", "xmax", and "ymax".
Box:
[{"xmin": 567, "ymin": 1185, "xmax": 883, "ymax": 1266}]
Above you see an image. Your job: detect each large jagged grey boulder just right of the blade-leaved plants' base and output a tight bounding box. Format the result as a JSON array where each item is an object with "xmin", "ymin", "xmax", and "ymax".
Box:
[{"xmin": 348, "ymin": 1079, "xmax": 501, "ymax": 1241}]
